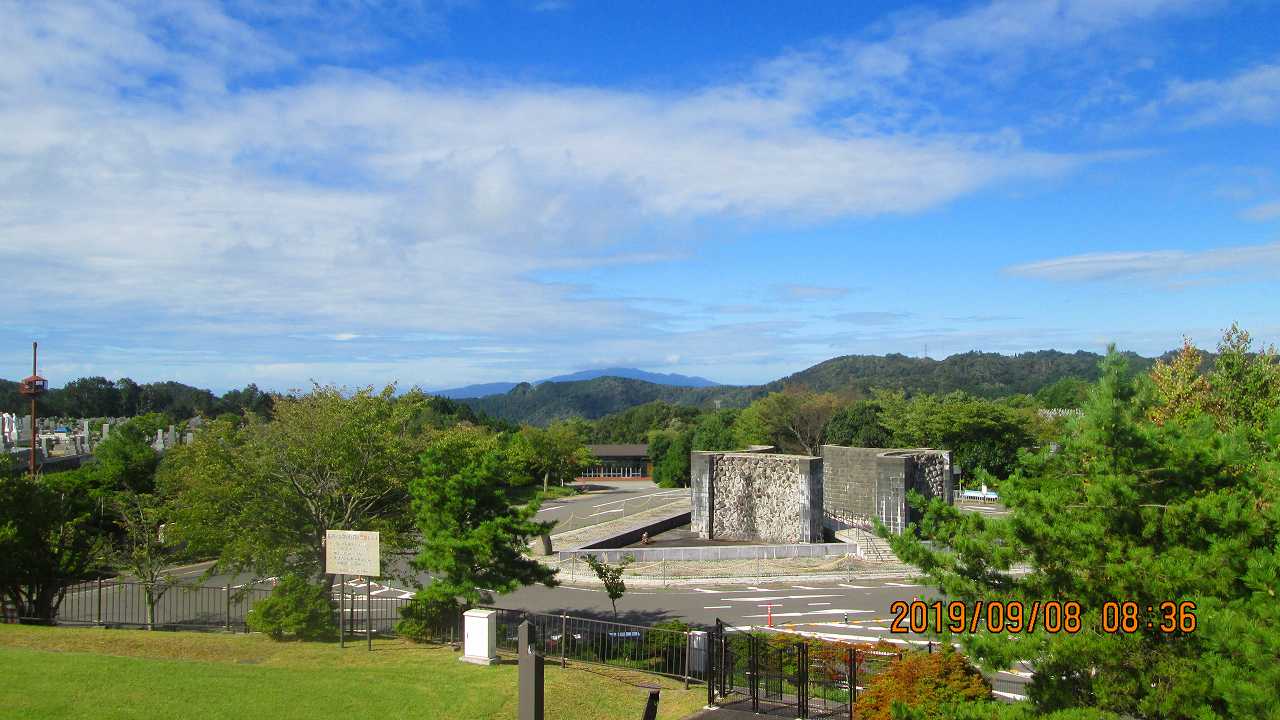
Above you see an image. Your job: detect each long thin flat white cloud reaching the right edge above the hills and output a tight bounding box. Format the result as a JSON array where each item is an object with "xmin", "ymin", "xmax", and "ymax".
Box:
[{"xmin": 1005, "ymin": 242, "xmax": 1280, "ymax": 282}]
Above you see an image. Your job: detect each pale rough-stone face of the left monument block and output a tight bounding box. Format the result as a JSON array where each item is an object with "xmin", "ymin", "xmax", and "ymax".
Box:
[{"xmin": 690, "ymin": 452, "xmax": 823, "ymax": 543}]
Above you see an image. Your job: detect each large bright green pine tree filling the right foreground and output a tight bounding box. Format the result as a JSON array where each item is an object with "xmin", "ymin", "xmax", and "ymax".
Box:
[{"xmin": 891, "ymin": 352, "xmax": 1280, "ymax": 719}]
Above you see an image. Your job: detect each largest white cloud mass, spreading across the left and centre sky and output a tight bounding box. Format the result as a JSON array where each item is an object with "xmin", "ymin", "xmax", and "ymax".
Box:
[{"xmin": 0, "ymin": 1, "xmax": 1218, "ymax": 380}]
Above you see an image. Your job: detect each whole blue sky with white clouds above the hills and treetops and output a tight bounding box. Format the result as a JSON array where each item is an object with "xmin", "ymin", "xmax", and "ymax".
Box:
[{"xmin": 0, "ymin": 0, "xmax": 1280, "ymax": 391}]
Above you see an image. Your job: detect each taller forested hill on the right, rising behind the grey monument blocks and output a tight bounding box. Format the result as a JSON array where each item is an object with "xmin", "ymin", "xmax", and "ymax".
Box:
[{"xmin": 764, "ymin": 350, "xmax": 1155, "ymax": 397}]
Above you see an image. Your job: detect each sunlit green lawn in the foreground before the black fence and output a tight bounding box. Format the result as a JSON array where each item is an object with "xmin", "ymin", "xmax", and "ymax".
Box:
[{"xmin": 0, "ymin": 625, "xmax": 707, "ymax": 720}]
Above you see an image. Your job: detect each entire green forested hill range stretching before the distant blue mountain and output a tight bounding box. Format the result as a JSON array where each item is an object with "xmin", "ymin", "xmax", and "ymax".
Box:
[{"xmin": 462, "ymin": 350, "xmax": 1155, "ymax": 424}]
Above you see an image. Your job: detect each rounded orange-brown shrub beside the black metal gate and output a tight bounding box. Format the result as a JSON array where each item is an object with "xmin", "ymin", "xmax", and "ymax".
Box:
[{"xmin": 858, "ymin": 646, "xmax": 991, "ymax": 720}]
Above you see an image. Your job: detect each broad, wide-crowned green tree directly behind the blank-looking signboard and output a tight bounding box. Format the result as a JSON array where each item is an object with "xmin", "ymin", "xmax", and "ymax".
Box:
[{"xmin": 160, "ymin": 386, "xmax": 421, "ymax": 582}]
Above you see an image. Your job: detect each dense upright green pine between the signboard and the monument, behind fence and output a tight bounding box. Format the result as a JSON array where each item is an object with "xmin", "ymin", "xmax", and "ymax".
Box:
[{"xmin": 407, "ymin": 425, "xmax": 556, "ymax": 616}]
